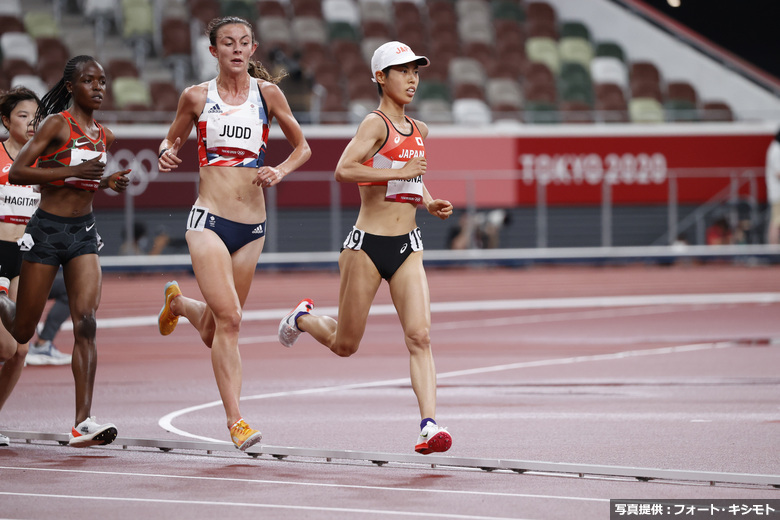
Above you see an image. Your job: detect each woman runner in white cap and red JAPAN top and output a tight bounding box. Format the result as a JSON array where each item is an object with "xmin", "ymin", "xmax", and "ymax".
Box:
[{"xmin": 279, "ymin": 41, "xmax": 452, "ymax": 454}]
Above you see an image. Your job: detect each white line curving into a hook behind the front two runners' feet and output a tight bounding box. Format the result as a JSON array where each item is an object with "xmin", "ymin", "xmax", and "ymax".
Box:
[{"xmin": 157, "ymin": 342, "xmax": 734, "ymax": 443}]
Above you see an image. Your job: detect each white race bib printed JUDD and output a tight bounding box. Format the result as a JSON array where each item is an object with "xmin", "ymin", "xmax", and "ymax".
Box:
[{"xmin": 206, "ymin": 114, "xmax": 263, "ymax": 159}]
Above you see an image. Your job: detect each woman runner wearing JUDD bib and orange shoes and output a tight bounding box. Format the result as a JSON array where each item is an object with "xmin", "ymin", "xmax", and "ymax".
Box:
[{"xmin": 158, "ymin": 17, "xmax": 311, "ymax": 450}]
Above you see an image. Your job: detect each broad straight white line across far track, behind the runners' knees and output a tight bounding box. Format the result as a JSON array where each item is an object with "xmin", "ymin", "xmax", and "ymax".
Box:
[{"xmin": 80, "ymin": 293, "xmax": 780, "ymax": 329}]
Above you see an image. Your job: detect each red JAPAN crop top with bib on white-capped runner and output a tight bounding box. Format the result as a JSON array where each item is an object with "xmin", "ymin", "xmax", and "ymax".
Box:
[{"xmin": 358, "ymin": 110, "xmax": 425, "ymax": 204}]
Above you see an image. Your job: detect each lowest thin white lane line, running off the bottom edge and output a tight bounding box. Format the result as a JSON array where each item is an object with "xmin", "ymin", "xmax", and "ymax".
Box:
[{"xmin": 0, "ymin": 491, "xmax": 532, "ymax": 520}]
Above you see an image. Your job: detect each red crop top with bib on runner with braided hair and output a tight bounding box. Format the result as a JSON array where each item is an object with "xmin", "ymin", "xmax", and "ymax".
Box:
[{"xmin": 38, "ymin": 111, "xmax": 106, "ymax": 191}]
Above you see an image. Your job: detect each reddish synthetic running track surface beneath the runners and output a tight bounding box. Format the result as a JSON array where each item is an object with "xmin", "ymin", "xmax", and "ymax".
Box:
[{"xmin": 0, "ymin": 265, "xmax": 780, "ymax": 520}]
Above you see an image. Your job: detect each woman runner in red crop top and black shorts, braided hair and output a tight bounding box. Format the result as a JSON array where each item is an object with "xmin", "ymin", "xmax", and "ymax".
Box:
[{"xmin": 0, "ymin": 56, "xmax": 130, "ymax": 447}]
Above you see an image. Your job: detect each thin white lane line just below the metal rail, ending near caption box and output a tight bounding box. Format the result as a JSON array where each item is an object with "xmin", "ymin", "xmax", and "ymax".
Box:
[{"xmin": 0, "ymin": 466, "xmax": 609, "ymax": 502}]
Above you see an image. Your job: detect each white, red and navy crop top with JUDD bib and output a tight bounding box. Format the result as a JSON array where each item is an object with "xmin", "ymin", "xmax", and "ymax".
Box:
[{"xmin": 198, "ymin": 78, "xmax": 270, "ymax": 168}]
